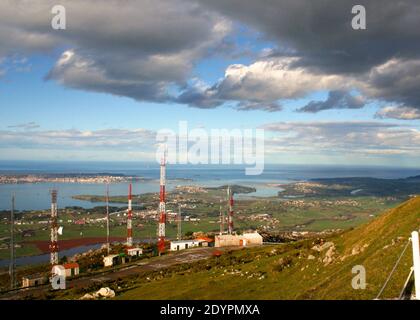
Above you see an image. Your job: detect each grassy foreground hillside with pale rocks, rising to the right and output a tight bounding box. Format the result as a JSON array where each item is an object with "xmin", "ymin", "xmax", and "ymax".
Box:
[{"xmin": 116, "ymin": 197, "xmax": 420, "ymax": 299}]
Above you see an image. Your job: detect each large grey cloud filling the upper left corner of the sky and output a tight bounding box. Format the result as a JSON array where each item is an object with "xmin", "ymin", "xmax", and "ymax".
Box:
[{"xmin": 0, "ymin": 0, "xmax": 231, "ymax": 102}]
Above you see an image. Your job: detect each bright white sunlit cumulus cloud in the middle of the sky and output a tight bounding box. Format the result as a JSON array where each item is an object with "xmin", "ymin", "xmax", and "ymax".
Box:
[{"xmin": 179, "ymin": 57, "xmax": 351, "ymax": 111}]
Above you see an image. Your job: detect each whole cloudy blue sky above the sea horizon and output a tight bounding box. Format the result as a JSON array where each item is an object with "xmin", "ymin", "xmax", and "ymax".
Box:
[{"xmin": 0, "ymin": 0, "xmax": 420, "ymax": 167}]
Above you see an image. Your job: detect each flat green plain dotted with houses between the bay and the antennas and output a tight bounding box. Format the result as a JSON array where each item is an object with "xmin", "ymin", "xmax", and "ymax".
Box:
[{"xmin": 0, "ymin": 189, "xmax": 401, "ymax": 259}]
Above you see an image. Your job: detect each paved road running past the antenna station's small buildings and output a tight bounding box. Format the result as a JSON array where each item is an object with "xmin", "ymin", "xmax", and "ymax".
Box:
[{"xmin": 0, "ymin": 247, "xmax": 231, "ymax": 300}]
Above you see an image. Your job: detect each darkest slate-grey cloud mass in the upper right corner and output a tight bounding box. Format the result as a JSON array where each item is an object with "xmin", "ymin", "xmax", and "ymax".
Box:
[{"xmin": 194, "ymin": 0, "xmax": 420, "ymax": 74}]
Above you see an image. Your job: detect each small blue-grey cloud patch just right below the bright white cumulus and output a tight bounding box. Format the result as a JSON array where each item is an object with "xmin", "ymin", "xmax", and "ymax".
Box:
[{"xmin": 298, "ymin": 90, "xmax": 365, "ymax": 113}]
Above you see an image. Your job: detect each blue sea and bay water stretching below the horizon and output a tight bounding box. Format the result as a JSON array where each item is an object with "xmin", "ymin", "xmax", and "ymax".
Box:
[{"xmin": 0, "ymin": 161, "xmax": 420, "ymax": 210}]
